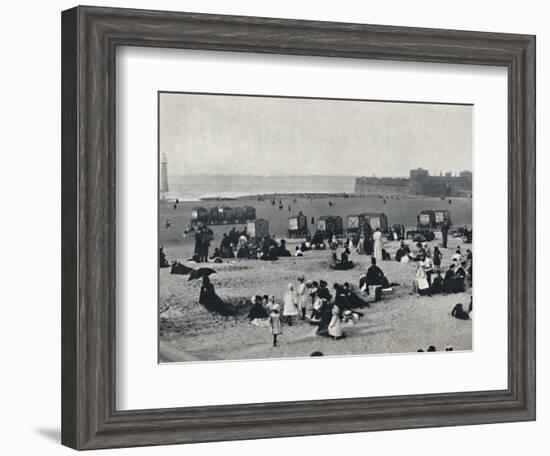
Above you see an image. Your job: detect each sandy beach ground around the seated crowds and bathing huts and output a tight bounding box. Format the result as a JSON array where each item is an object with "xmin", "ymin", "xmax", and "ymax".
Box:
[{"xmin": 159, "ymin": 196, "xmax": 472, "ymax": 362}]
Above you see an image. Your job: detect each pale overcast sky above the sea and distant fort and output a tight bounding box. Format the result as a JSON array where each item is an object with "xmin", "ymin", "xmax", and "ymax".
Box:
[{"xmin": 159, "ymin": 93, "xmax": 472, "ymax": 177}]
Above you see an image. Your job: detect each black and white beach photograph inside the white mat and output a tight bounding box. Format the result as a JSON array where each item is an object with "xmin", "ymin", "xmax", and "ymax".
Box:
[{"xmin": 158, "ymin": 92, "xmax": 474, "ymax": 363}]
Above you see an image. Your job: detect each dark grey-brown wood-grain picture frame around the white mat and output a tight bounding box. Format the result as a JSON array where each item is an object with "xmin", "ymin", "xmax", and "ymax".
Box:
[{"xmin": 62, "ymin": 7, "xmax": 536, "ymax": 449}]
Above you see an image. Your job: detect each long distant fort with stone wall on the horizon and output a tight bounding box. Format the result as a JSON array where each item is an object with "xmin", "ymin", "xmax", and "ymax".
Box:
[{"xmin": 355, "ymin": 168, "xmax": 472, "ymax": 196}]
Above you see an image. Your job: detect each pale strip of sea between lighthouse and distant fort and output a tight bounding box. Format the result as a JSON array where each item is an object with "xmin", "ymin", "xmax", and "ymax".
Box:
[{"xmin": 164, "ymin": 175, "xmax": 355, "ymax": 201}]
